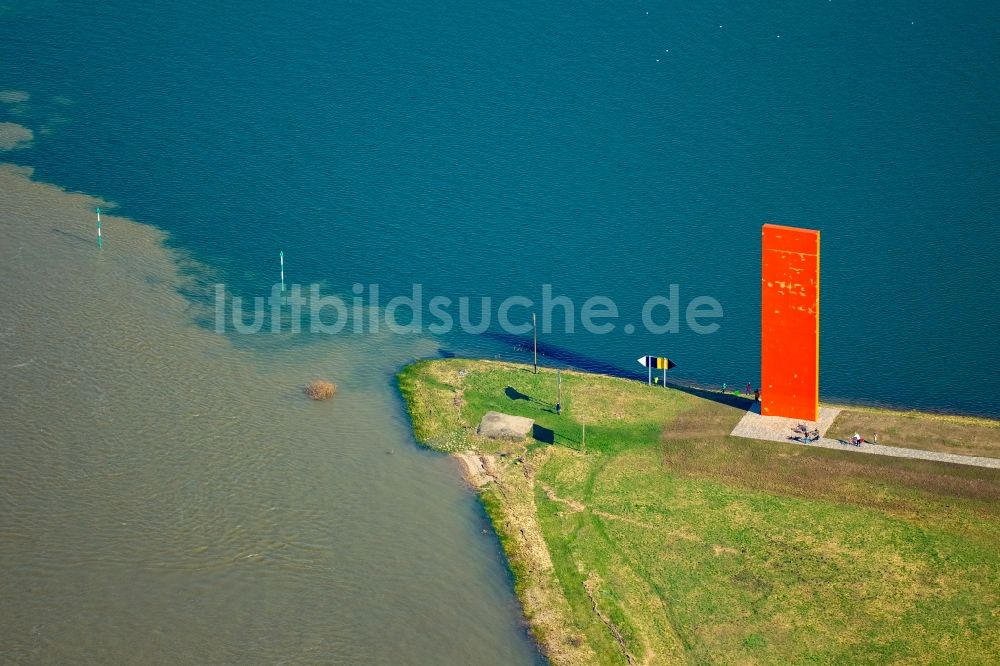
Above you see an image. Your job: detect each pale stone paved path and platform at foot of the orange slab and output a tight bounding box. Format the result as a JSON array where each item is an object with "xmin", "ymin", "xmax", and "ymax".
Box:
[{"xmin": 730, "ymin": 403, "xmax": 1000, "ymax": 469}]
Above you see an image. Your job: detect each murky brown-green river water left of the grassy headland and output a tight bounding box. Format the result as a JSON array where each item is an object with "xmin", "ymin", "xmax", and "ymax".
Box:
[{"xmin": 0, "ymin": 166, "xmax": 538, "ymax": 663}]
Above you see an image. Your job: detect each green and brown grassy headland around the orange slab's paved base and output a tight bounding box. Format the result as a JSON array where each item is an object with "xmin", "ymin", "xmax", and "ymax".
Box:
[{"xmin": 399, "ymin": 359, "xmax": 1000, "ymax": 664}]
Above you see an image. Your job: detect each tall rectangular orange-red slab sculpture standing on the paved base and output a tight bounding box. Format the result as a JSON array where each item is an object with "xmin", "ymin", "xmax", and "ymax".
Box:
[{"xmin": 760, "ymin": 224, "xmax": 819, "ymax": 421}]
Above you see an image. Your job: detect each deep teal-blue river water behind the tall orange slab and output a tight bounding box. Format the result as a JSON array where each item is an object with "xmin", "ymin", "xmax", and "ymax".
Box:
[{"xmin": 0, "ymin": 0, "xmax": 1000, "ymax": 416}]
